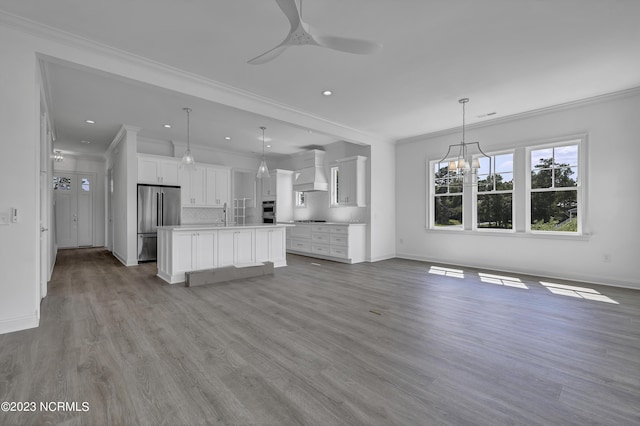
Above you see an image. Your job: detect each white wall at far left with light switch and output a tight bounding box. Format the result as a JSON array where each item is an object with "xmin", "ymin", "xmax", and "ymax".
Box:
[{"xmin": 0, "ymin": 27, "xmax": 40, "ymax": 333}]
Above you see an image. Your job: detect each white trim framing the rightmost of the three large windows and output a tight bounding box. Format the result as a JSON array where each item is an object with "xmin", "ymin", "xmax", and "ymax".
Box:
[{"xmin": 525, "ymin": 134, "xmax": 588, "ymax": 236}]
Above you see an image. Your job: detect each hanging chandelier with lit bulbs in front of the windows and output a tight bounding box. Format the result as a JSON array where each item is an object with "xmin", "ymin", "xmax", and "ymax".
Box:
[{"xmin": 440, "ymin": 98, "xmax": 489, "ymax": 185}]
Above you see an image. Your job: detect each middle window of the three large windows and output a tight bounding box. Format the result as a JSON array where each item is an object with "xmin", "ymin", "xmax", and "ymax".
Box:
[{"xmin": 475, "ymin": 153, "xmax": 513, "ymax": 229}]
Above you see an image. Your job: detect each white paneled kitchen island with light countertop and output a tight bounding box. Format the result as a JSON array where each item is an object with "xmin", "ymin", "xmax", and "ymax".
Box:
[{"xmin": 158, "ymin": 224, "xmax": 292, "ymax": 284}]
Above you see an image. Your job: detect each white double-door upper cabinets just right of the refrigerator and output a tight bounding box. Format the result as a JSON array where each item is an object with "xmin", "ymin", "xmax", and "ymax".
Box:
[{"xmin": 180, "ymin": 165, "xmax": 231, "ymax": 207}]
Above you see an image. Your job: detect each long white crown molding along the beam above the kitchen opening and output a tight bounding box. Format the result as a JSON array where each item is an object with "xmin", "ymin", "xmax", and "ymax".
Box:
[{"xmin": 0, "ymin": 10, "xmax": 395, "ymax": 145}]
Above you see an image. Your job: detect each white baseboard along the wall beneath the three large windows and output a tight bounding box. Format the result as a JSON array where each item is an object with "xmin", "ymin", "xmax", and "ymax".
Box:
[{"xmin": 396, "ymin": 253, "xmax": 640, "ymax": 290}]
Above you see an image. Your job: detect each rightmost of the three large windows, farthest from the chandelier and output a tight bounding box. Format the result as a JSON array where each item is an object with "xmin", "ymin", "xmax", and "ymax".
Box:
[{"xmin": 527, "ymin": 141, "xmax": 581, "ymax": 232}]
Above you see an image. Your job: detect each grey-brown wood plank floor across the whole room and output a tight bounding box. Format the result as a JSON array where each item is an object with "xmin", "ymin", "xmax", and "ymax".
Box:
[{"xmin": 0, "ymin": 249, "xmax": 640, "ymax": 425}]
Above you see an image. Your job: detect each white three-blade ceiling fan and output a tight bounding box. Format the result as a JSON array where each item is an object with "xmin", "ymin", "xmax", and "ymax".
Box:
[{"xmin": 248, "ymin": 0, "xmax": 382, "ymax": 65}]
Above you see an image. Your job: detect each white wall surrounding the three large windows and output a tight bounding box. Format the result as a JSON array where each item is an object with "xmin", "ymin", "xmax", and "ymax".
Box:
[{"xmin": 396, "ymin": 91, "xmax": 640, "ymax": 288}]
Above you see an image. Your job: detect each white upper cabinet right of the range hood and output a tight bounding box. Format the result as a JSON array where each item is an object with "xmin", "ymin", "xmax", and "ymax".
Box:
[{"xmin": 331, "ymin": 155, "xmax": 367, "ymax": 207}]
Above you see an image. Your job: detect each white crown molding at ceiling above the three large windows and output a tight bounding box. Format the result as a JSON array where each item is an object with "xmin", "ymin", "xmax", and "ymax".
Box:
[{"xmin": 396, "ymin": 87, "xmax": 640, "ymax": 145}]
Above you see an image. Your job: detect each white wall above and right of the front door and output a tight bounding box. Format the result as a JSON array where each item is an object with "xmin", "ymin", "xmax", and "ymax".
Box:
[{"xmin": 54, "ymin": 154, "xmax": 106, "ymax": 247}]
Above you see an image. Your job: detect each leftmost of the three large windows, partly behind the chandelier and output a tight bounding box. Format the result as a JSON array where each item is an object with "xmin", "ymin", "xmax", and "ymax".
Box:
[{"xmin": 431, "ymin": 162, "xmax": 463, "ymax": 228}]
